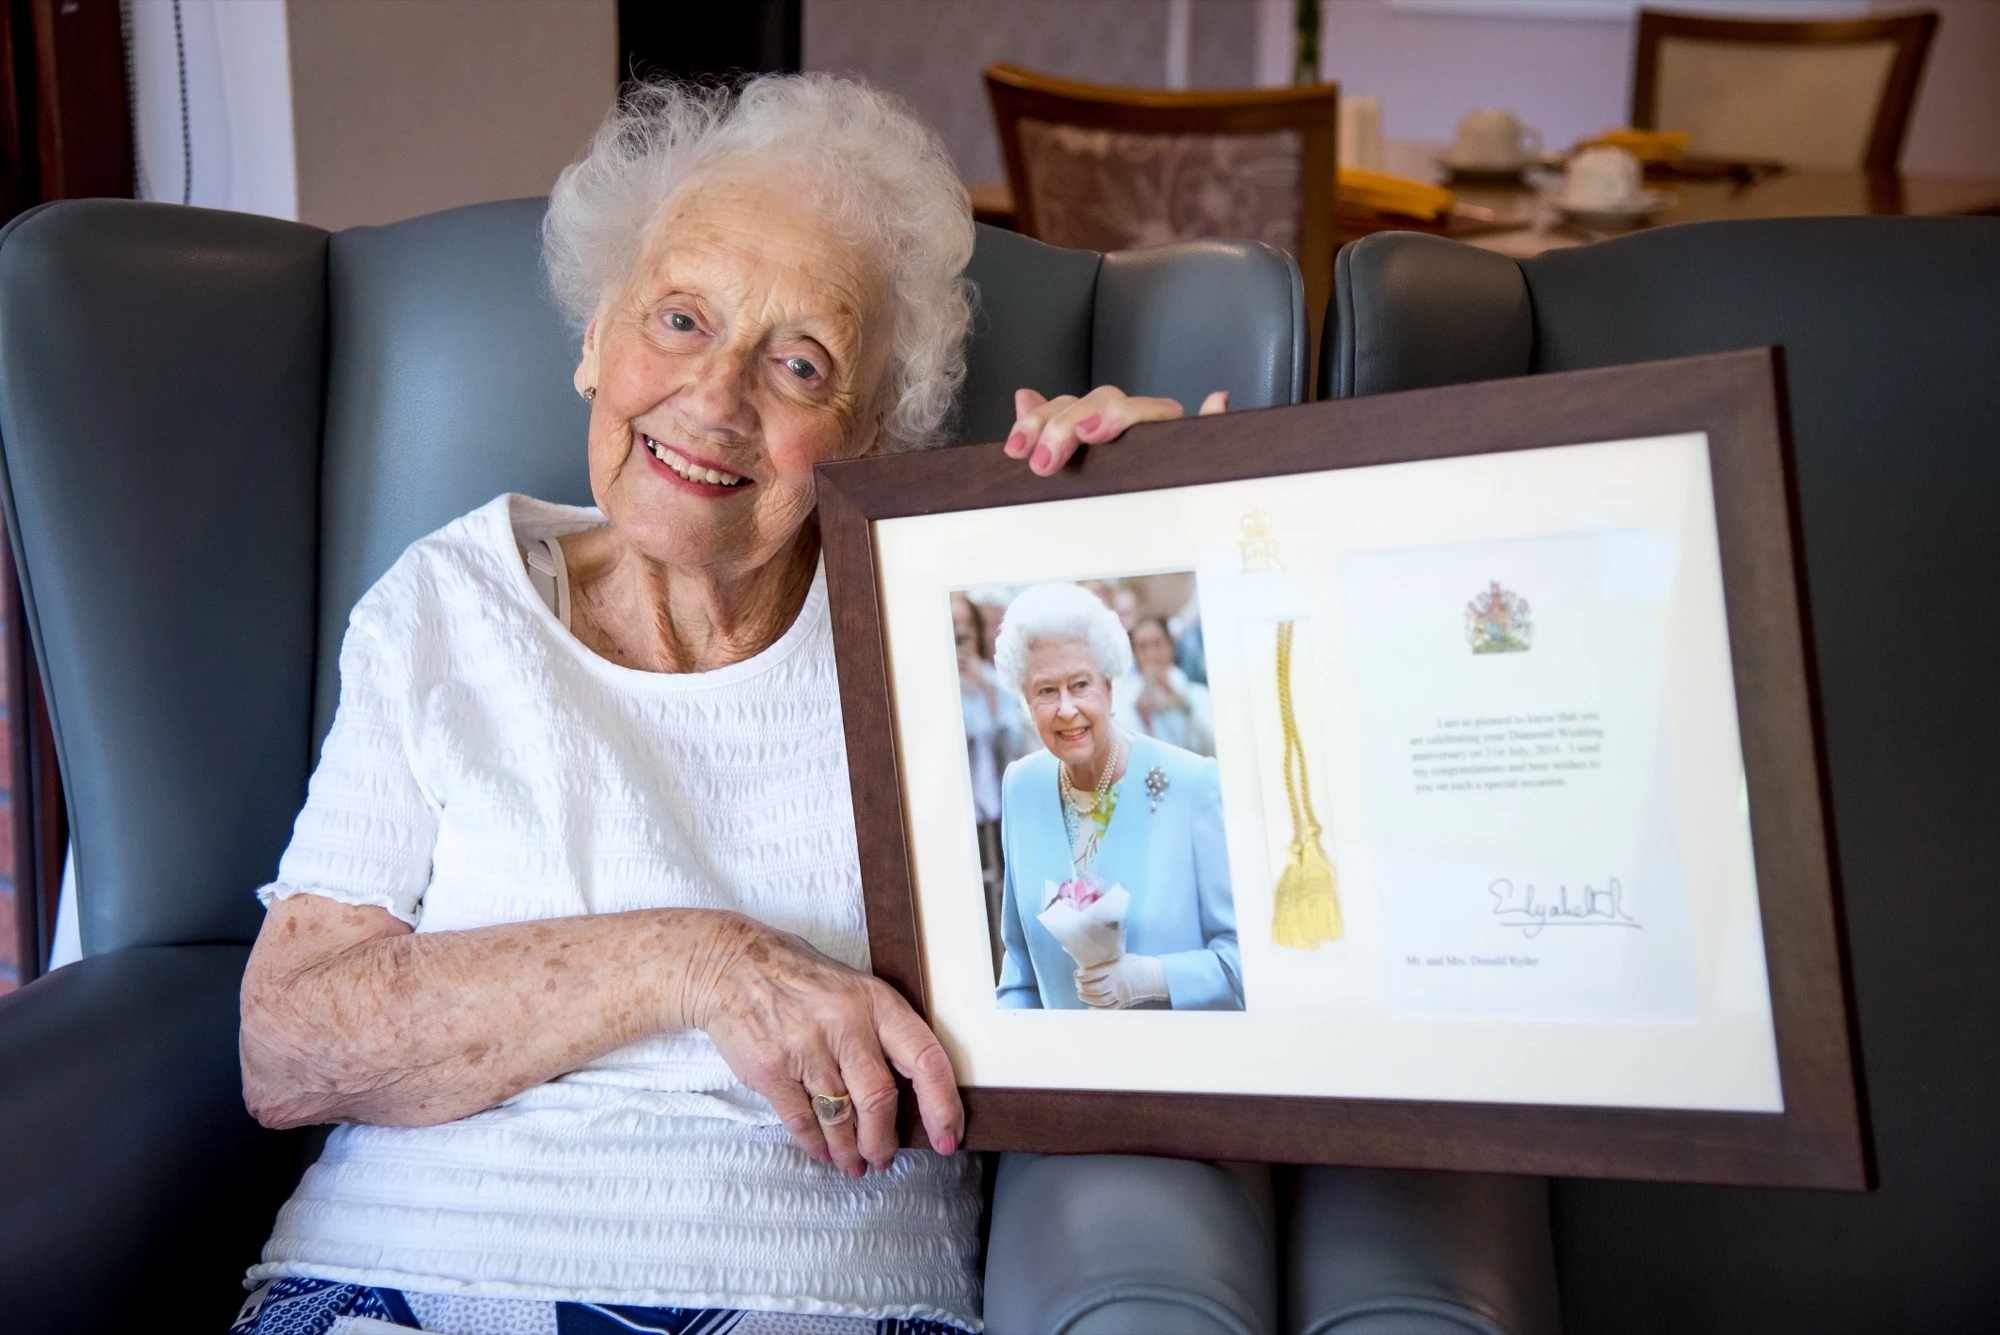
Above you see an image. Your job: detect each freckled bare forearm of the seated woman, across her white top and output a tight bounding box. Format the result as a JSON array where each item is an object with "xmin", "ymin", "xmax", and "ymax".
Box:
[{"xmin": 242, "ymin": 909, "xmax": 740, "ymax": 1125}]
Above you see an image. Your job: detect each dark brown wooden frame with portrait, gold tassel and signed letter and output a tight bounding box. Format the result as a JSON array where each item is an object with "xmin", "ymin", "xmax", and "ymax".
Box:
[{"xmin": 820, "ymin": 350, "xmax": 1872, "ymax": 1189}]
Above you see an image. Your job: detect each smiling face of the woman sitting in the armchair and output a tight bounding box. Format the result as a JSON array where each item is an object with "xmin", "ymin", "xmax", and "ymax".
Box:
[{"xmin": 576, "ymin": 176, "xmax": 886, "ymax": 574}]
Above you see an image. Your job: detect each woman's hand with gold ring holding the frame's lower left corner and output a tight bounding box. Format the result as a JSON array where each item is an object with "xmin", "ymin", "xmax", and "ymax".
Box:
[{"xmin": 690, "ymin": 913, "xmax": 966, "ymax": 1177}]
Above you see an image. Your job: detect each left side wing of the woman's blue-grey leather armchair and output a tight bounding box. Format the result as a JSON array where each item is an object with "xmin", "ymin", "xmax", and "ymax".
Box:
[{"xmin": 0, "ymin": 200, "xmax": 326, "ymax": 953}]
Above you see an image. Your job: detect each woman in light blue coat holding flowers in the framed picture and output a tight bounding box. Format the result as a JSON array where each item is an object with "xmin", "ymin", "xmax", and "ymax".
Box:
[{"xmin": 994, "ymin": 584, "xmax": 1244, "ymax": 1011}]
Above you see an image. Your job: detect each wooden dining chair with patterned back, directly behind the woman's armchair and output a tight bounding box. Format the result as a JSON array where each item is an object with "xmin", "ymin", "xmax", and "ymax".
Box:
[{"xmin": 986, "ymin": 64, "xmax": 1340, "ymax": 377}]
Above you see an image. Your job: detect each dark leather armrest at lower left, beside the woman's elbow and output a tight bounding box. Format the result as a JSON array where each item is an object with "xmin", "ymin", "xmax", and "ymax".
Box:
[{"xmin": 0, "ymin": 945, "xmax": 300, "ymax": 1331}]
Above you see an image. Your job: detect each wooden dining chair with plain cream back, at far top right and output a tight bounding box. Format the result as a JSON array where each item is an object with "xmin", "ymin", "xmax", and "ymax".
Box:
[{"xmin": 1632, "ymin": 10, "xmax": 1938, "ymax": 172}]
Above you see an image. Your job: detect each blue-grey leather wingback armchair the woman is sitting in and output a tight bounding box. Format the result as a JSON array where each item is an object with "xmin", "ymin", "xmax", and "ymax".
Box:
[{"xmin": 0, "ymin": 200, "xmax": 1554, "ymax": 1335}]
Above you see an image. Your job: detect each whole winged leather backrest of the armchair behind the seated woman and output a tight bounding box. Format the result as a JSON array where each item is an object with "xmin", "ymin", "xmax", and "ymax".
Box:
[{"xmin": 0, "ymin": 200, "xmax": 1306, "ymax": 953}]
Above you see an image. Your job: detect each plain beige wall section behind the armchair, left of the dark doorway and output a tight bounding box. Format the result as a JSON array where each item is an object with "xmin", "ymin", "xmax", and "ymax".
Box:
[{"xmin": 286, "ymin": 0, "xmax": 618, "ymax": 228}]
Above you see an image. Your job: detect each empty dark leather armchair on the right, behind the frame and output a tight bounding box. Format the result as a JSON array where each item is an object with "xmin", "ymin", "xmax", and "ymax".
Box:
[{"xmin": 1320, "ymin": 218, "xmax": 2000, "ymax": 1335}]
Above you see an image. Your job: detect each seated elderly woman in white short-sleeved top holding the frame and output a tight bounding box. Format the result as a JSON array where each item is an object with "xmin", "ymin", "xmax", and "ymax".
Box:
[{"xmin": 238, "ymin": 76, "xmax": 1220, "ymax": 1335}]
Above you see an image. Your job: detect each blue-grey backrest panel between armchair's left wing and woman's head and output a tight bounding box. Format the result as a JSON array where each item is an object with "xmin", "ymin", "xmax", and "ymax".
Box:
[{"xmin": 314, "ymin": 200, "xmax": 590, "ymax": 755}]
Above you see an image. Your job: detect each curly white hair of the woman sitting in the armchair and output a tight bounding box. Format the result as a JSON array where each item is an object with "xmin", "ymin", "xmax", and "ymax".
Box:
[{"xmin": 542, "ymin": 74, "xmax": 972, "ymax": 450}]
